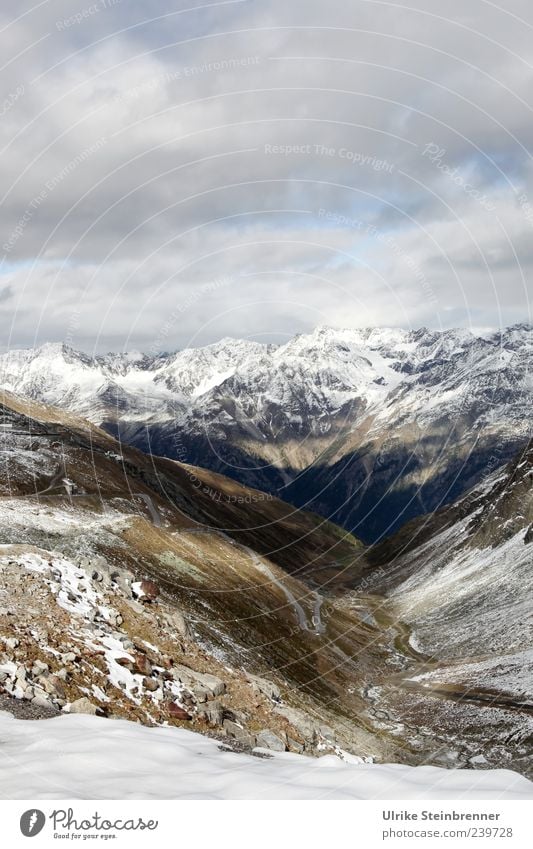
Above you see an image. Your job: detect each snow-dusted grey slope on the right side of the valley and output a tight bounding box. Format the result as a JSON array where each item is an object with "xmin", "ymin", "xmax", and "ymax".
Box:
[{"xmin": 345, "ymin": 443, "xmax": 533, "ymax": 774}]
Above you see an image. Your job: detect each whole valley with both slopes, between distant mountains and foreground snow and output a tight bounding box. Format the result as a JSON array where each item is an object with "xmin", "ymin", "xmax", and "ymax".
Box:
[{"xmin": 0, "ymin": 384, "xmax": 533, "ymax": 775}]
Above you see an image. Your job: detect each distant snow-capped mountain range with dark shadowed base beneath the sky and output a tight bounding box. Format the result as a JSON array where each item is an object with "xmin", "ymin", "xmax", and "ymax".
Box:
[{"xmin": 0, "ymin": 325, "xmax": 533, "ymax": 541}]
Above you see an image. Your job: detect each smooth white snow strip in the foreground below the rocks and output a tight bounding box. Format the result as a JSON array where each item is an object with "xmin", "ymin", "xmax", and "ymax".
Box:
[{"xmin": 0, "ymin": 713, "xmax": 533, "ymax": 800}]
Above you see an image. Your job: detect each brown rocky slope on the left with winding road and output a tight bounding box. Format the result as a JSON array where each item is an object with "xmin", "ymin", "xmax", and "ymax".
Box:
[{"xmin": 0, "ymin": 395, "xmax": 386, "ymax": 758}]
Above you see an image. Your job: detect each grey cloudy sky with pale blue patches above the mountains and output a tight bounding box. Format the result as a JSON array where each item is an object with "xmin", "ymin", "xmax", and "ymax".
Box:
[{"xmin": 0, "ymin": 0, "xmax": 533, "ymax": 352}]
